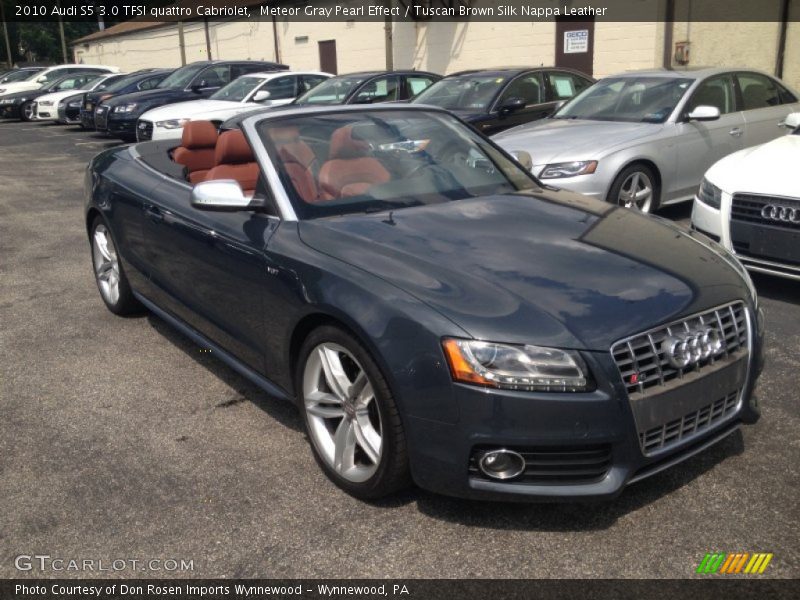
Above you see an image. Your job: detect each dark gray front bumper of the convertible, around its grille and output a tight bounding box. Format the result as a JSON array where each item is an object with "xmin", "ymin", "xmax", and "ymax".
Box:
[{"xmin": 407, "ymin": 315, "xmax": 763, "ymax": 501}]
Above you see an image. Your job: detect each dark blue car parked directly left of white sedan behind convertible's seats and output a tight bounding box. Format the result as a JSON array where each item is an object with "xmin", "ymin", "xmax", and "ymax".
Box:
[{"xmin": 95, "ymin": 60, "xmax": 289, "ymax": 141}]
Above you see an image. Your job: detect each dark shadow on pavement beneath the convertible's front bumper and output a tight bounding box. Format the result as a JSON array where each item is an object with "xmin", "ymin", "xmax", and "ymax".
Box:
[{"xmin": 392, "ymin": 430, "xmax": 744, "ymax": 532}]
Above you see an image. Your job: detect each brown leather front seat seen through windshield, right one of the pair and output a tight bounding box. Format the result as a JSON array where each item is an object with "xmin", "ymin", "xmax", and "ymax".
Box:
[{"xmin": 319, "ymin": 125, "xmax": 391, "ymax": 200}]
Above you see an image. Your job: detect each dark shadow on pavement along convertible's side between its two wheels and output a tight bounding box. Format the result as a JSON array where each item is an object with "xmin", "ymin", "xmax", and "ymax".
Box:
[{"xmin": 146, "ymin": 313, "xmax": 304, "ymax": 433}]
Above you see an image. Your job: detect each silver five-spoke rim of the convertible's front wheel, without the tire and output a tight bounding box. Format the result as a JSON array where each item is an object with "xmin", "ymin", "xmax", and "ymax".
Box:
[{"xmin": 303, "ymin": 342, "xmax": 383, "ymax": 483}]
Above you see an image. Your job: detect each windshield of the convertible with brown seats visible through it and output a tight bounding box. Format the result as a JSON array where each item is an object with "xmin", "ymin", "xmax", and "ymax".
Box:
[{"xmin": 259, "ymin": 110, "xmax": 536, "ymax": 219}]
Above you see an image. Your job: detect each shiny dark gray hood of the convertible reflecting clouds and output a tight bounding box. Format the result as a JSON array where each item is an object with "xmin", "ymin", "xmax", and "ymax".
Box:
[{"xmin": 300, "ymin": 191, "xmax": 747, "ymax": 350}]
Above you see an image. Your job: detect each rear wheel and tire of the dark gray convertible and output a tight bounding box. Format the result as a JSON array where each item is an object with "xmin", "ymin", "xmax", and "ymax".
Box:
[{"xmin": 89, "ymin": 215, "xmax": 144, "ymax": 315}]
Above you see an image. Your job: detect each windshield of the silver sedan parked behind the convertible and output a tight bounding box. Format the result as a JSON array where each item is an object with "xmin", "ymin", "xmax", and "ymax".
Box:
[{"xmin": 553, "ymin": 77, "xmax": 693, "ymax": 123}]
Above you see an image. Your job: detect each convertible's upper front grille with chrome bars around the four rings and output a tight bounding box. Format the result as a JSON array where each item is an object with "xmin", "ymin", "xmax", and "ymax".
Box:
[{"xmin": 611, "ymin": 302, "xmax": 748, "ymax": 397}]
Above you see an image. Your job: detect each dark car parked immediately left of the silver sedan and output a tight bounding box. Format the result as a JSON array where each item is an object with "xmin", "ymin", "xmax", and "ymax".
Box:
[{"xmin": 411, "ymin": 67, "xmax": 594, "ymax": 135}]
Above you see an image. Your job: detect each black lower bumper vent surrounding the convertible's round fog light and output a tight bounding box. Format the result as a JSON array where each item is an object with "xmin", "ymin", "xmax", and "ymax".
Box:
[{"xmin": 469, "ymin": 444, "xmax": 611, "ymax": 485}]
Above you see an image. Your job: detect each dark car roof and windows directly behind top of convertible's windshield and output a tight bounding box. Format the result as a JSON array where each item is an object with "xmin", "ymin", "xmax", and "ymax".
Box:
[{"xmin": 294, "ymin": 71, "xmax": 442, "ymax": 106}]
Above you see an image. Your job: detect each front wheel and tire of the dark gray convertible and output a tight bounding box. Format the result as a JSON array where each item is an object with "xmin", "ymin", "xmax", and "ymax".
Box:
[{"xmin": 295, "ymin": 326, "xmax": 411, "ymax": 500}]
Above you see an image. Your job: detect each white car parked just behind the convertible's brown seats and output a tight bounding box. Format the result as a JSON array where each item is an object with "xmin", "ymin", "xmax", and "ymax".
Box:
[{"xmin": 136, "ymin": 71, "xmax": 333, "ymax": 142}]
